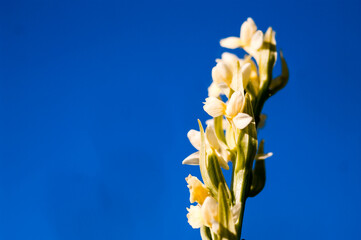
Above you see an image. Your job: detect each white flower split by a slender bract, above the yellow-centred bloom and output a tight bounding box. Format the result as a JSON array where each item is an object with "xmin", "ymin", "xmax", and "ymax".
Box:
[{"xmin": 182, "ymin": 125, "xmax": 229, "ymax": 170}]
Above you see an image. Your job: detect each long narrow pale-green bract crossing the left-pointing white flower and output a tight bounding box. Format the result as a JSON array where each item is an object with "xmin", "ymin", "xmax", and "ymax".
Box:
[{"xmin": 198, "ymin": 119, "xmax": 220, "ymax": 198}]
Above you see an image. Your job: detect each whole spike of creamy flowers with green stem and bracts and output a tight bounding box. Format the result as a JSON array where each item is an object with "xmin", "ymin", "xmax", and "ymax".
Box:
[{"xmin": 183, "ymin": 18, "xmax": 288, "ymax": 240}]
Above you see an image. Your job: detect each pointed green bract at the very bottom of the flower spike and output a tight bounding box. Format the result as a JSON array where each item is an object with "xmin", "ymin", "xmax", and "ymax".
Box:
[{"xmin": 218, "ymin": 183, "xmax": 236, "ymax": 240}]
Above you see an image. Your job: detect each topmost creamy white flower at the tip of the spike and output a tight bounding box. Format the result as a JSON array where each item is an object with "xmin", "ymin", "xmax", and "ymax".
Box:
[{"xmin": 220, "ymin": 18, "xmax": 263, "ymax": 59}]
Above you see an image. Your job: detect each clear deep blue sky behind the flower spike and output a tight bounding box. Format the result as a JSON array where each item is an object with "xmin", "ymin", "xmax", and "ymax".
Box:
[{"xmin": 0, "ymin": 0, "xmax": 361, "ymax": 240}]
